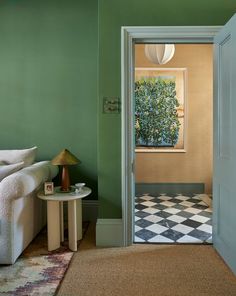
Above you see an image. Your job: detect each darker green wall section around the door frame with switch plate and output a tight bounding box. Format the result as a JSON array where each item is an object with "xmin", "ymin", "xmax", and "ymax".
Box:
[{"xmin": 98, "ymin": 0, "xmax": 236, "ymax": 218}]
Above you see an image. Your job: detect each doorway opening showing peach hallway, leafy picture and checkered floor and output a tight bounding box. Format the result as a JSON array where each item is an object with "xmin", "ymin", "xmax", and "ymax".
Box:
[{"xmin": 133, "ymin": 43, "xmax": 213, "ymax": 244}]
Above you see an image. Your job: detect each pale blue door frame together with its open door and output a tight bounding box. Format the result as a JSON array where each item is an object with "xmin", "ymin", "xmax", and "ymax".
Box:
[{"xmin": 121, "ymin": 19, "xmax": 236, "ymax": 273}]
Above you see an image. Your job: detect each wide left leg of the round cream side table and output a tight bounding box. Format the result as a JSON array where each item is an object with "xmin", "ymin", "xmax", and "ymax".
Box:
[{"xmin": 47, "ymin": 200, "xmax": 60, "ymax": 251}]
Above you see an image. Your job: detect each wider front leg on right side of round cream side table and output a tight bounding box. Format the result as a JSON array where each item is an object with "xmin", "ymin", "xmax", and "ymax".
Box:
[{"xmin": 68, "ymin": 200, "xmax": 77, "ymax": 251}]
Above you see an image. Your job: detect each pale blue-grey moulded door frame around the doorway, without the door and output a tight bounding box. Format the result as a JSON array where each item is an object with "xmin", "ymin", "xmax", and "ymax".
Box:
[{"xmin": 121, "ymin": 26, "xmax": 222, "ymax": 246}]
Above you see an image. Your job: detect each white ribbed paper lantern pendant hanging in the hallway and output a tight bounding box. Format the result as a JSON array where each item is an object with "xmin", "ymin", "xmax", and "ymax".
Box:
[{"xmin": 145, "ymin": 44, "xmax": 175, "ymax": 65}]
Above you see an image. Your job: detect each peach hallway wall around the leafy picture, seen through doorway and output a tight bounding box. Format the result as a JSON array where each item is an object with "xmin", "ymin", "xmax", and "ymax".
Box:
[{"xmin": 135, "ymin": 44, "xmax": 213, "ymax": 193}]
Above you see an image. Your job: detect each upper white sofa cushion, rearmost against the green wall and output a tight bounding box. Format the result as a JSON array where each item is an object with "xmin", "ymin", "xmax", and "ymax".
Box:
[{"xmin": 0, "ymin": 147, "xmax": 38, "ymax": 167}]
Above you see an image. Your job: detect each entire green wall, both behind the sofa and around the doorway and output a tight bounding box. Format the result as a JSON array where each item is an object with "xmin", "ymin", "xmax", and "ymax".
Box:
[{"xmin": 0, "ymin": 0, "xmax": 236, "ymax": 218}]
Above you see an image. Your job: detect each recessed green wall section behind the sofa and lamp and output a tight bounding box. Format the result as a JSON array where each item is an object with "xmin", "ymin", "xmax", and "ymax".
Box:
[{"xmin": 0, "ymin": 0, "xmax": 98, "ymax": 198}]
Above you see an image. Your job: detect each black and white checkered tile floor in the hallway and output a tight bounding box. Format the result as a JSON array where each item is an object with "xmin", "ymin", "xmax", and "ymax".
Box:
[{"xmin": 134, "ymin": 194, "xmax": 212, "ymax": 243}]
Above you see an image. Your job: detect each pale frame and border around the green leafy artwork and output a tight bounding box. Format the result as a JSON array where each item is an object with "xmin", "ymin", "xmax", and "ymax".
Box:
[{"xmin": 135, "ymin": 67, "xmax": 187, "ymax": 153}]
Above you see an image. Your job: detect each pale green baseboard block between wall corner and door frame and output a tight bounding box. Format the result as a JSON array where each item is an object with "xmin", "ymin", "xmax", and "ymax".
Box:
[{"xmin": 96, "ymin": 219, "xmax": 123, "ymax": 247}]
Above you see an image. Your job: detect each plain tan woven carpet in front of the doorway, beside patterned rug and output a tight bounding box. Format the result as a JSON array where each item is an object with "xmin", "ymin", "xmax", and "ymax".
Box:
[{"xmin": 58, "ymin": 226, "xmax": 236, "ymax": 296}]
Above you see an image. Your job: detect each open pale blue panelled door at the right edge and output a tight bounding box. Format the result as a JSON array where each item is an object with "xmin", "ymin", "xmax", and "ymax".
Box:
[{"xmin": 213, "ymin": 15, "xmax": 236, "ymax": 273}]
